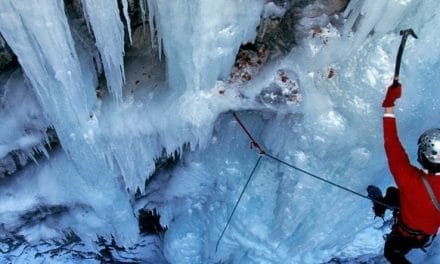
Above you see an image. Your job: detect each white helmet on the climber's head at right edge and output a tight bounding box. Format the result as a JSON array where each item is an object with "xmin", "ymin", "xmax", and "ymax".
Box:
[{"xmin": 417, "ymin": 128, "xmax": 440, "ymax": 173}]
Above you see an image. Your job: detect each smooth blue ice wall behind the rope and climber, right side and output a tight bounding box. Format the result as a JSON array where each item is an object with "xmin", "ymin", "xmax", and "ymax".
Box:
[{"xmin": 138, "ymin": 1, "xmax": 440, "ymax": 263}]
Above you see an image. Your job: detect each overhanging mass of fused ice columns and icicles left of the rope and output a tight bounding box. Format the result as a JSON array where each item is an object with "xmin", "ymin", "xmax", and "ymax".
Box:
[{"xmin": 0, "ymin": 0, "xmax": 270, "ymax": 248}]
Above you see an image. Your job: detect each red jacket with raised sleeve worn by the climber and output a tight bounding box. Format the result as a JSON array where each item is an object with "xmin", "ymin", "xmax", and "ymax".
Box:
[{"xmin": 383, "ymin": 115, "xmax": 440, "ymax": 234}]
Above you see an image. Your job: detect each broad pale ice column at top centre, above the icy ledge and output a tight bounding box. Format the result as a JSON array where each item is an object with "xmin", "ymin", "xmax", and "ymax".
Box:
[{"xmin": 148, "ymin": 0, "xmax": 265, "ymax": 91}]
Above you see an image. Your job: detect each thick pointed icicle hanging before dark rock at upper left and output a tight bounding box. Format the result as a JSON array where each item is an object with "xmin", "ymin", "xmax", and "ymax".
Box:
[{"xmin": 82, "ymin": 0, "xmax": 125, "ymax": 102}]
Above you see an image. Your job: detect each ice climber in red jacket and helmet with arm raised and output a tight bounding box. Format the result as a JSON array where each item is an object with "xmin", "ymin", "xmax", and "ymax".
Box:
[{"xmin": 367, "ymin": 81, "xmax": 440, "ymax": 264}]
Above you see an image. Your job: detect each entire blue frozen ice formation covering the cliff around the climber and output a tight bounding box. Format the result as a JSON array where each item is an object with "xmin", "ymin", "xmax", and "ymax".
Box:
[{"xmin": 0, "ymin": 0, "xmax": 440, "ymax": 263}]
